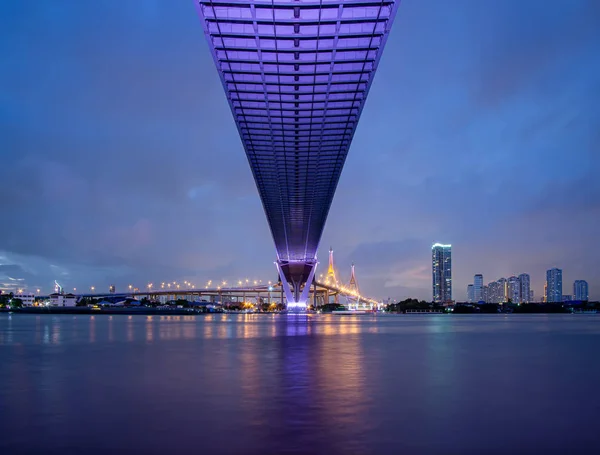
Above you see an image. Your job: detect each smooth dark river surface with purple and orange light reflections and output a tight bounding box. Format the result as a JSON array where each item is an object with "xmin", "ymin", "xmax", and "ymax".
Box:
[{"xmin": 0, "ymin": 314, "xmax": 600, "ymax": 454}]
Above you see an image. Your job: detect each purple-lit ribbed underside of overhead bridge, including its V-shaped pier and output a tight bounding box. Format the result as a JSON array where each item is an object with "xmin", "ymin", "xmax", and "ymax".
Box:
[{"xmin": 195, "ymin": 0, "xmax": 399, "ymax": 309}]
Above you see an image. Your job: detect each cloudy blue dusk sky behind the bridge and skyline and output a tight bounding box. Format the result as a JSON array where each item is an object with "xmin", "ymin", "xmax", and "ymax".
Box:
[{"xmin": 0, "ymin": 0, "xmax": 600, "ymax": 300}]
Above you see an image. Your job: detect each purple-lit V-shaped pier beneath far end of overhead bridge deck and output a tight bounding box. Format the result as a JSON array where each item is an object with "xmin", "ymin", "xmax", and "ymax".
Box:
[{"xmin": 275, "ymin": 261, "xmax": 317, "ymax": 313}]
